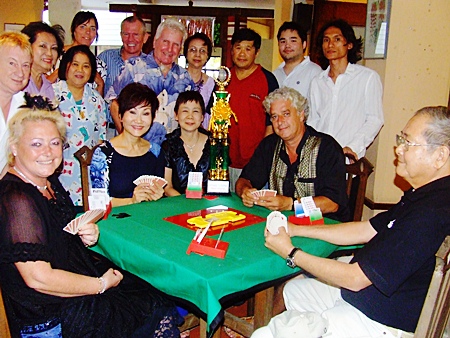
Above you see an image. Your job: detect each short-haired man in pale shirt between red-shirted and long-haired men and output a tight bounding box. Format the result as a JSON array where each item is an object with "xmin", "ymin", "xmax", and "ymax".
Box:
[{"xmin": 273, "ymin": 21, "xmax": 322, "ymax": 98}]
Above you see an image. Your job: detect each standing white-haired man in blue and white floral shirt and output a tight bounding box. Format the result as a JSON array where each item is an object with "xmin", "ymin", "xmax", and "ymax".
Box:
[{"xmin": 106, "ymin": 19, "xmax": 194, "ymax": 144}]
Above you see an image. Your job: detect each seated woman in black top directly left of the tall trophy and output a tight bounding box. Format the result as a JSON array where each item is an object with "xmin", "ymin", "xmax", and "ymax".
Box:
[{"xmin": 162, "ymin": 91, "xmax": 210, "ymax": 196}]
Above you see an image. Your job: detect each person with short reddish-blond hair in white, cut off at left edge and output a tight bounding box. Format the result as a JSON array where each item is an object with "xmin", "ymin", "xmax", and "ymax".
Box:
[{"xmin": 0, "ymin": 32, "xmax": 32, "ymax": 178}]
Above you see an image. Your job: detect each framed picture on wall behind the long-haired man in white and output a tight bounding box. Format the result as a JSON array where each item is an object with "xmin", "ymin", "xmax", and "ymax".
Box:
[{"xmin": 364, "ymin": 0, "xmax": 392, "ymax": 59}]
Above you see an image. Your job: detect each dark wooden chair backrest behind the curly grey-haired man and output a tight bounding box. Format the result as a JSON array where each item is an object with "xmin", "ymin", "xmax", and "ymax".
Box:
[{"xmin": 345, "ymin": 157, "xmax": 373, "ymax": 221}]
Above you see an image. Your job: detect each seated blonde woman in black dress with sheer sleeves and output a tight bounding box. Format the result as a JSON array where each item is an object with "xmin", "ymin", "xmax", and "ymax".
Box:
[{"xmin": 0, "ymin": 101, "xmax": 181, "ymax": 338}]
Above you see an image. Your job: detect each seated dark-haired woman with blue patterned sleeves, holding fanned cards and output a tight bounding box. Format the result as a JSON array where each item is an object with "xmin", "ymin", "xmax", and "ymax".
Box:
[{"xmin": 90, "ymin": 83, "xmax": 164, "ymax": 206}]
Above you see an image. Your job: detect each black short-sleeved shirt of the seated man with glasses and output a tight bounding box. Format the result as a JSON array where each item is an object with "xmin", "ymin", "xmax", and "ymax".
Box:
[{"xmin": 342, "ymin": 176, "xmax": 450, "ymax": 332}]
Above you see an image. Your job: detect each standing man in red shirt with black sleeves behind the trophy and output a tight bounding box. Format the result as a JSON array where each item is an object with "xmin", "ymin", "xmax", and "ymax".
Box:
[{"xmin": 227, "ymin": 28, "xmax": 278, "ymax": 191}]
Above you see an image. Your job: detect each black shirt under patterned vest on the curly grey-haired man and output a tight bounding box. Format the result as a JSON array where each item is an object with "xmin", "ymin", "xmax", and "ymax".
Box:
[{"xmin": 240, "ymin": 126, "xmax": 350, "ymax": 221}]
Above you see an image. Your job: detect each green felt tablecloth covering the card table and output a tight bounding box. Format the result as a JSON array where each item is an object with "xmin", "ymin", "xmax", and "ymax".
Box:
[{"xmin": 92, "ymin": 194, "xmax": 337, "ymax": 332}]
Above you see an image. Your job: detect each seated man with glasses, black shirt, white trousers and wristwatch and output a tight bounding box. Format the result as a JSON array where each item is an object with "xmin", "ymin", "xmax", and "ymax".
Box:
[{"xmin": 252, "ymin": 107, "xmax": 450, "ymax": 338}]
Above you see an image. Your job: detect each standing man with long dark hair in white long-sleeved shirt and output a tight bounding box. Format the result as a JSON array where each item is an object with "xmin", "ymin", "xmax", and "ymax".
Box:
[{"xmin": 308, "ymin": 20, "xmax": 384, "ymax": 160}]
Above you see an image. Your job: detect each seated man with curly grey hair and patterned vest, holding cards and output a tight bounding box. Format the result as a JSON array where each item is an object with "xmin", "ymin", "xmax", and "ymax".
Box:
[{"xmin": 236, "ymin": 87, "xmax": 349, "ymax": 221}]
